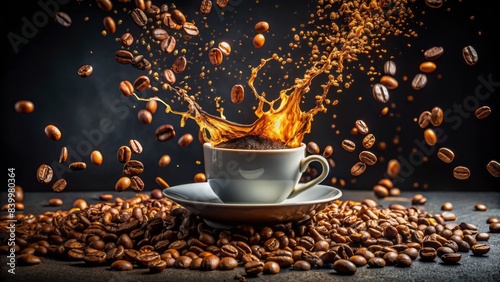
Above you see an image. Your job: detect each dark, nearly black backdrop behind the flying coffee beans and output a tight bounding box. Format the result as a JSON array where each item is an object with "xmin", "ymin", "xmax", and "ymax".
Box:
[{"xmin": 1, "ymin": 0, "xmax": 500, "ymax": 192}]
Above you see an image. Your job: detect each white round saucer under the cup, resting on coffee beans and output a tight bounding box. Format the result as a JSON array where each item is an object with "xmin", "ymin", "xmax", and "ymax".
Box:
[{"xmin": 163, "ymin": 182, "xmax": 342, "ymax": 228}]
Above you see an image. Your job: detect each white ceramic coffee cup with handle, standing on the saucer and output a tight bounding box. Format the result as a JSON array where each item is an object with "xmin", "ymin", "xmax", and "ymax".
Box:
[{"xmin": 203, "ymin": 143, "xmax": 329, "ymax": 204}]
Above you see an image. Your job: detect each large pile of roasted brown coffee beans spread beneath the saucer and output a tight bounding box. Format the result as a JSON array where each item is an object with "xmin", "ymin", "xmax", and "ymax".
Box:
[{"xmin": 0, "ymin": 193, "xmax": 500, "ymax": 278}]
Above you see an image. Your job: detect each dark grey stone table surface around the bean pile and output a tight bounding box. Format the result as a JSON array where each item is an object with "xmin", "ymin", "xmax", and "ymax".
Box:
[{"xmin": 0, "ymin": 191, "xmax": 500, "ymax": 282}]
